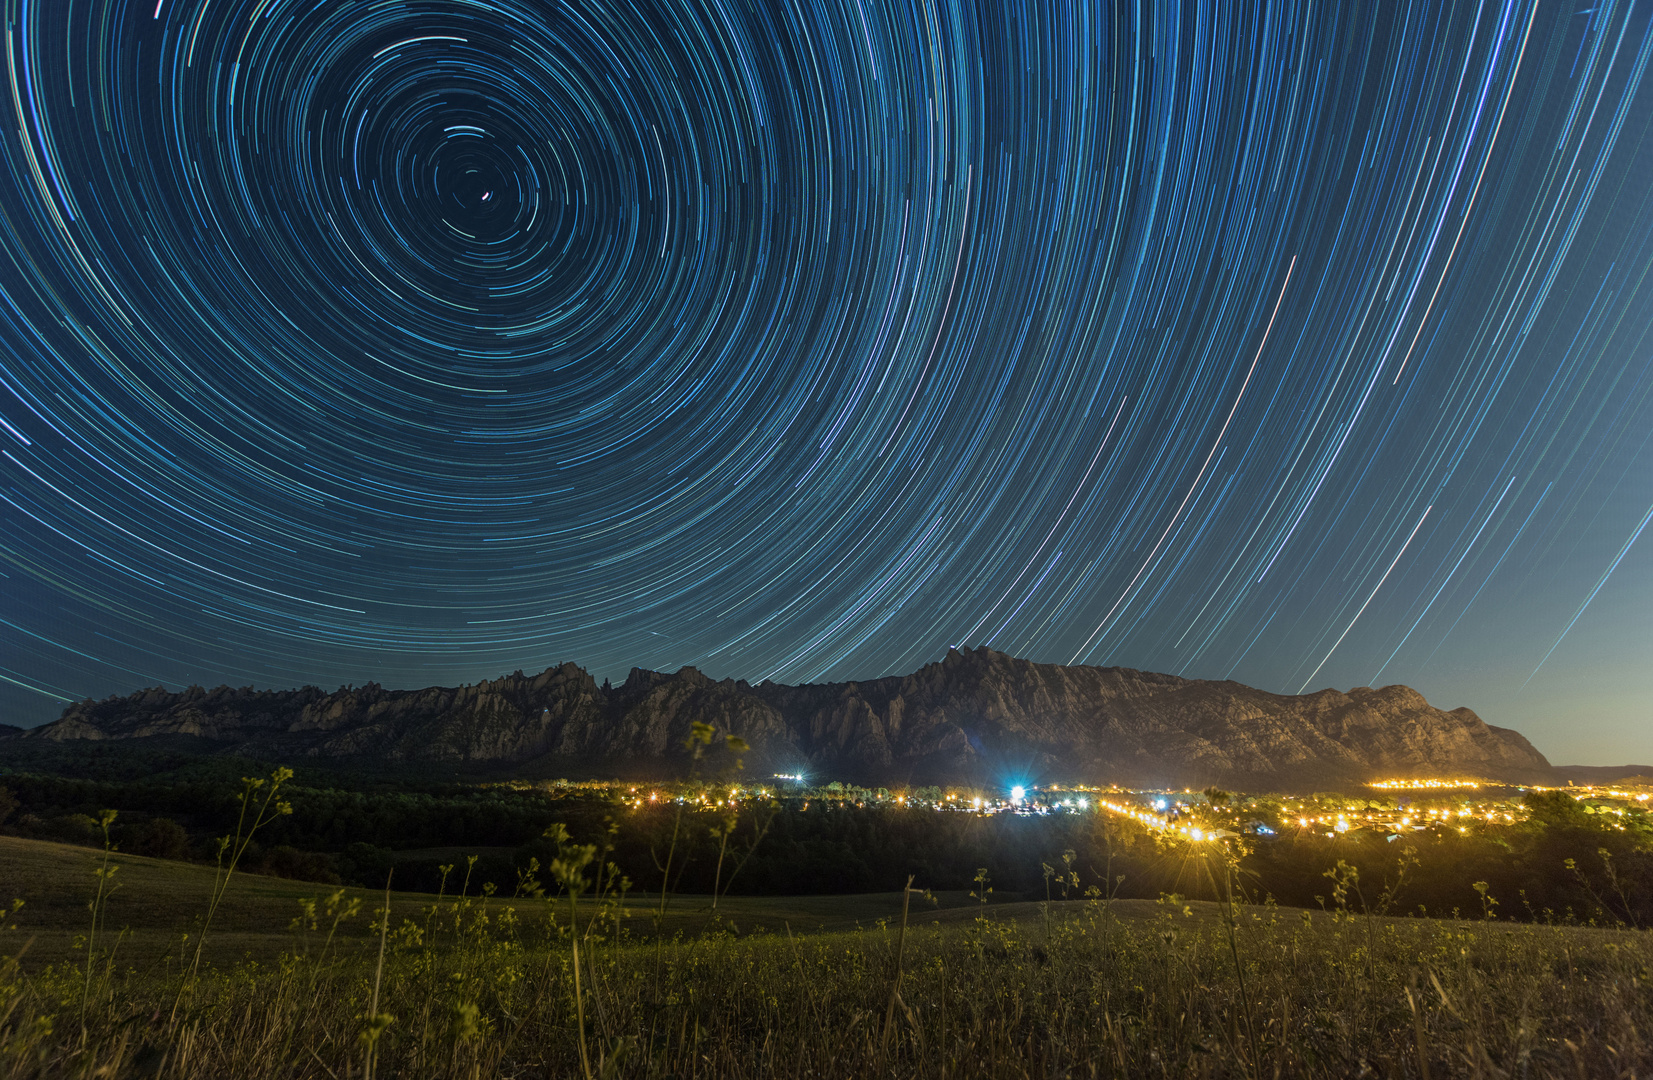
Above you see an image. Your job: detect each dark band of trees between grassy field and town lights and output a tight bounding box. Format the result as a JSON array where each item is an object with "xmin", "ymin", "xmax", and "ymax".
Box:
[{"xmin": 7, "ymin": 757, "xmax": 1653, "ymax": 926}]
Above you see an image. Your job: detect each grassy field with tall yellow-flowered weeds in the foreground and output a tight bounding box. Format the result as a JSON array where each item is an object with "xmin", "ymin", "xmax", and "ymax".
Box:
[{"xmin": 0, "ymin": 839, "xmax": 1653, "ymax": 1080}]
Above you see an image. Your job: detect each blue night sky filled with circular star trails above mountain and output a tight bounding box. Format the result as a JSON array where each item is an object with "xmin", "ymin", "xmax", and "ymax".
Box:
[{"xmin": 0, "ymin": 0, "xmax": 1653, "ymax": 762}]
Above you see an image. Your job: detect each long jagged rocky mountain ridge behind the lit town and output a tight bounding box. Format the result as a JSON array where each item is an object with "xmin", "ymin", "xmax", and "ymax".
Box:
[{"xmin": 19, "ymin": 648, "xmax": 1552, "ymax": 787}]
